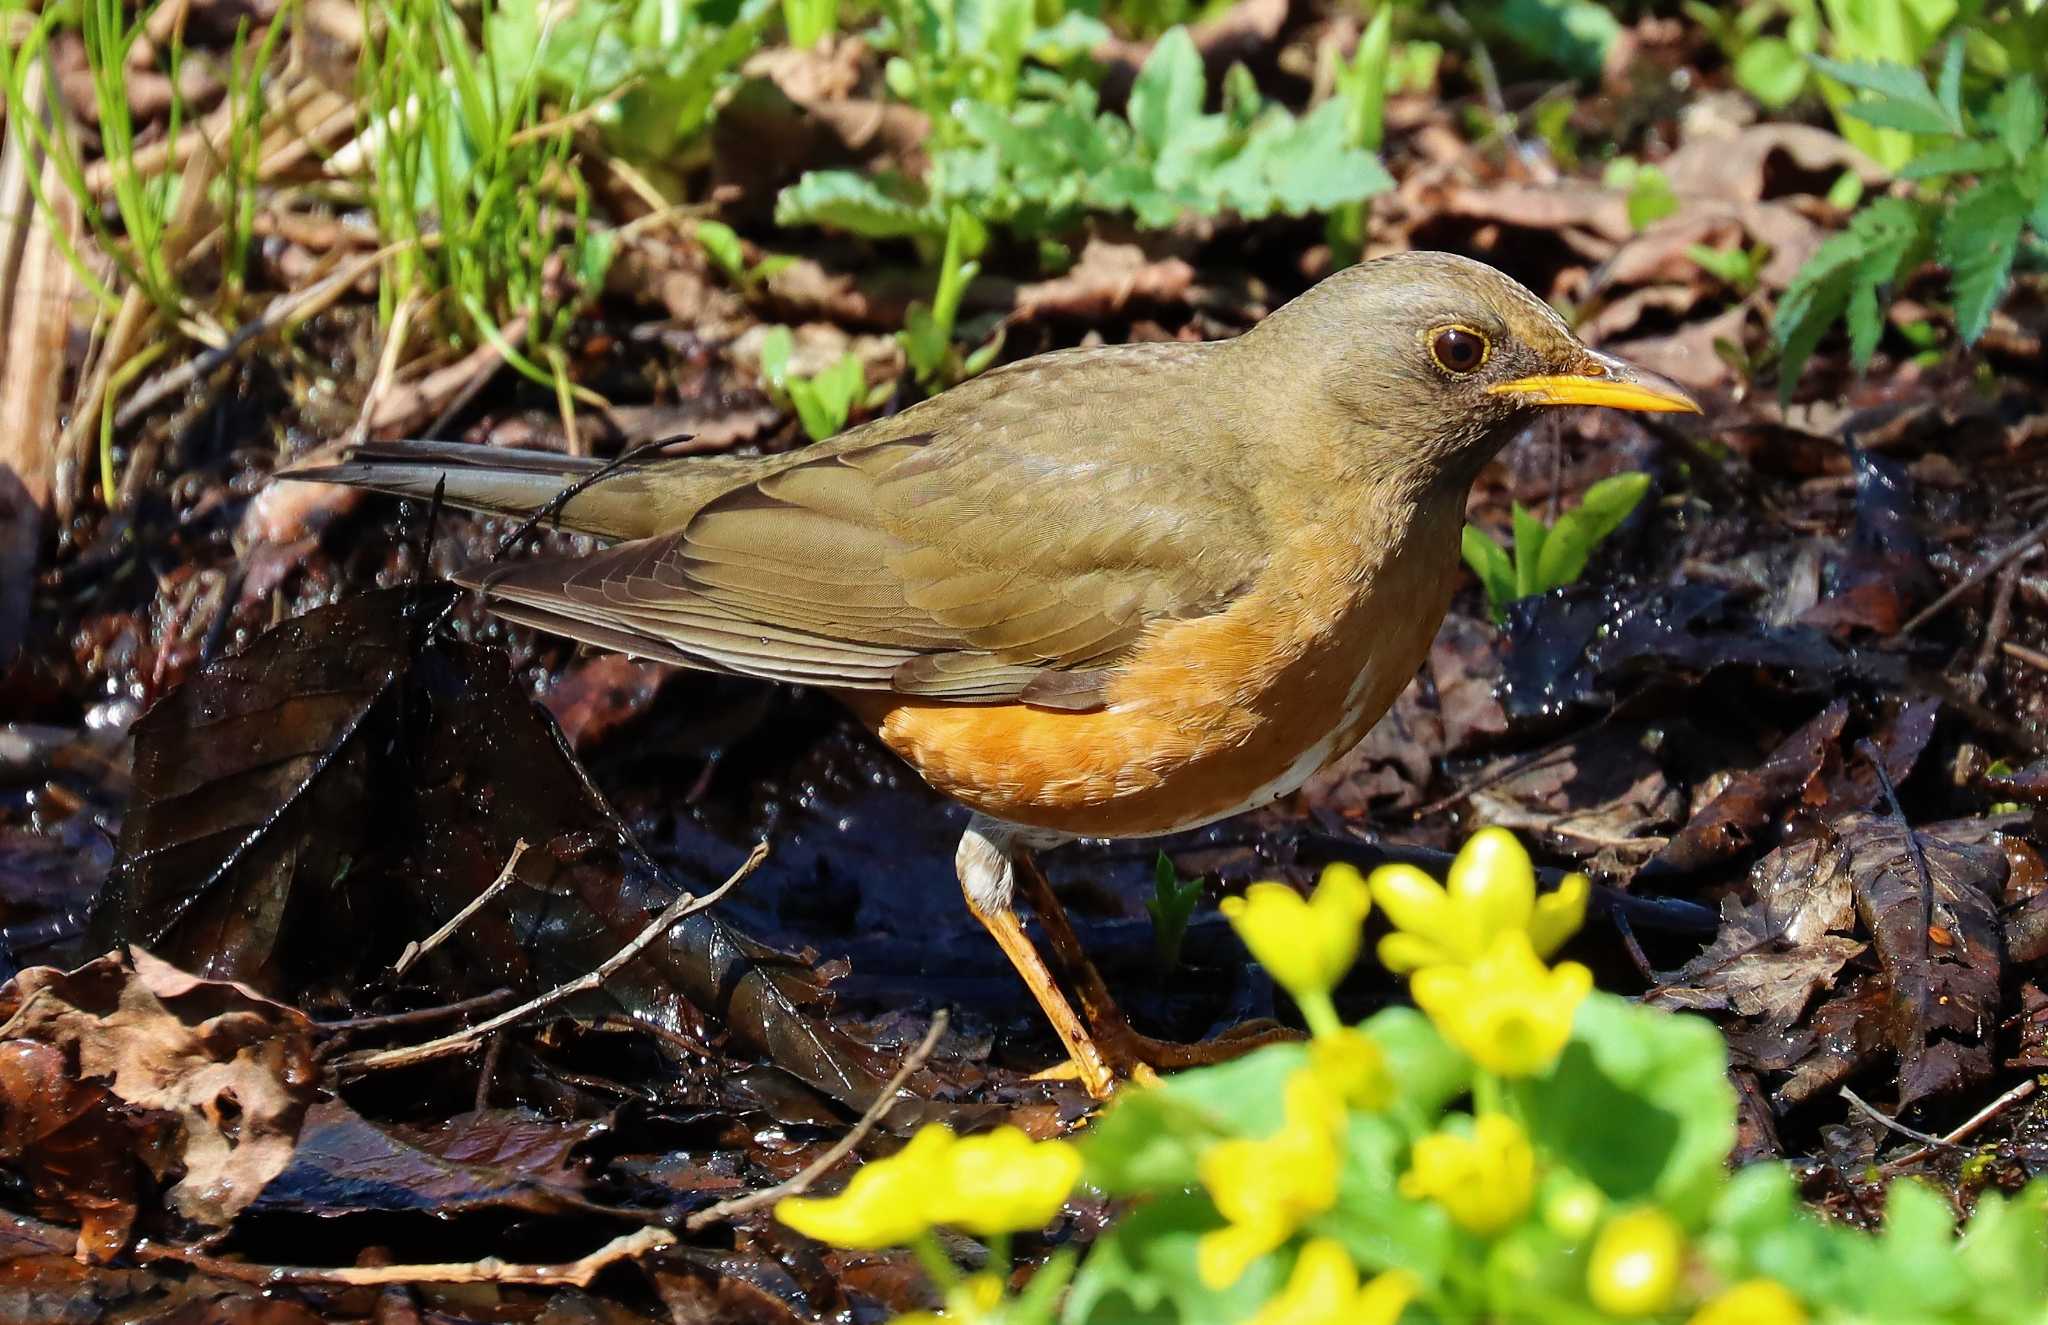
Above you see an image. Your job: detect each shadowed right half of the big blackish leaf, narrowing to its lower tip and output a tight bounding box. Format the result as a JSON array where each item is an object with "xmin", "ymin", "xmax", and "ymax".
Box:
[{"xmin": 408, "ymin": 630, "xmax": 889, "ymax": 1106}]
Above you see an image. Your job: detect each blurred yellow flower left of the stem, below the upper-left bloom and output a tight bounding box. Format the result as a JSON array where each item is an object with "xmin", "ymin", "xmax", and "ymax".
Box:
[{"xmin": 1194, "ymin": 1071, "xmax": 1346, "ymax": 1288}]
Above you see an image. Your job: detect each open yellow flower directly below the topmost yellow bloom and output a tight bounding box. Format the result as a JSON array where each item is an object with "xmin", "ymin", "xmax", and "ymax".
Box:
[{"xmin": 1409, "ymin": 930, "xmax": 1593, "ymax": 1077}]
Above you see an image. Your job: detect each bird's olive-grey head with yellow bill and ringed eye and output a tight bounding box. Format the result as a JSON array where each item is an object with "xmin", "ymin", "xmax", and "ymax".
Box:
[{"xmin": 1243, "ymin": 252, "xmax": 1700, "ymax": 487}]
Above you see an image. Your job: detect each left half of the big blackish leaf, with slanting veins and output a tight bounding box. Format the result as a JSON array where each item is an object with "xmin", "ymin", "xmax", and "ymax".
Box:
[{"xmin": 92, "ymin": 590, "xmax": 453, "ymax": 991}]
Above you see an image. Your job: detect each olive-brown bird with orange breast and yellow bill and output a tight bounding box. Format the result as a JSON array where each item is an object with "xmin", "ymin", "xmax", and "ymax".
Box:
[{"xmin": 281, "ymin": 252, "xmax": 1700, "ymax": 1098}]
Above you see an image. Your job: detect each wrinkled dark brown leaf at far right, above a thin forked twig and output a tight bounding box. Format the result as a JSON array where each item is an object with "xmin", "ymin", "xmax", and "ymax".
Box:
[{"xmin": 1841, "ymin": 815, "xmax": 2005, "ymax": 1108}]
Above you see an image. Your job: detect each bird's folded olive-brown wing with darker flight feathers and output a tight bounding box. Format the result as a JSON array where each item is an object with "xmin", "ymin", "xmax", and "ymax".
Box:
[{"xmin": 475, "ymin": 348, "xmax": 1266, "ymax": 709}]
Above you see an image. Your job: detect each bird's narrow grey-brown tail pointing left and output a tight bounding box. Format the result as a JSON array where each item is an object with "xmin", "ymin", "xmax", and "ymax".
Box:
[{"xmin": 276, "ymin": 442, "xmax": 692, "ymax": 539}]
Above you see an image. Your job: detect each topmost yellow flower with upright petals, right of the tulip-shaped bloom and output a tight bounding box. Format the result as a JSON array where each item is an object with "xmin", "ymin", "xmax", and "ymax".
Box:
[{"xmin": 1370, "ymin": 827, "xmax": 1593, "ymax": 975}]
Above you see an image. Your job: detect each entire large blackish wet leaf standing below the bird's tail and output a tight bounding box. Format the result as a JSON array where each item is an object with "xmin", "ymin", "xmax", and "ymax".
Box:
[{"xmin": 92, "ymin": 588, "xmax": 887, "ymax": 1106}]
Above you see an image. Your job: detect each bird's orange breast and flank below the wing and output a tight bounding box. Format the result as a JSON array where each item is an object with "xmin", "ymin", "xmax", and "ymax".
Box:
[{"xmin": 842, "ymin": 499, "xmax": 1454, "ymax": 838}]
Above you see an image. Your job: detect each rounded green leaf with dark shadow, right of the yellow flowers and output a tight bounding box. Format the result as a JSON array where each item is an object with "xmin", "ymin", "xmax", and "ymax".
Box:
[{"xmin": 1511, "ymin": 991, "xmax": 1735, "ymax": 1223}]
